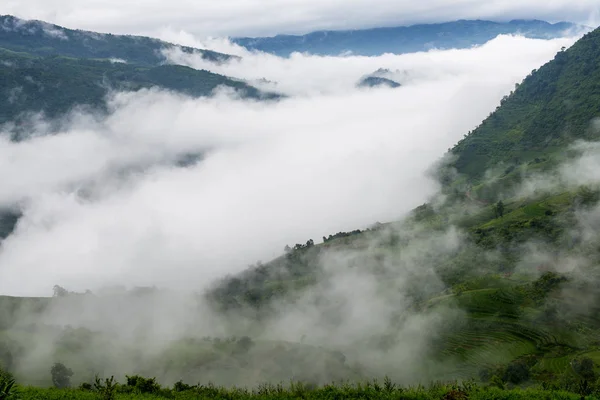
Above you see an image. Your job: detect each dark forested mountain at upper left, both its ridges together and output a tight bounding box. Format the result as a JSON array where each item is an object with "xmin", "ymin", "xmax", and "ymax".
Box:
[{"xmin": 0, "ymin": 16, "xmax": 280, "ymax": 130}]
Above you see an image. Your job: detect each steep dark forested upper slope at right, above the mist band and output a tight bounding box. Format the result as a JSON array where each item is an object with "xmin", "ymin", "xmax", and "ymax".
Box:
[{"xmin": 451, "ymin": 25, "xmax": 600, "ymax": 183}]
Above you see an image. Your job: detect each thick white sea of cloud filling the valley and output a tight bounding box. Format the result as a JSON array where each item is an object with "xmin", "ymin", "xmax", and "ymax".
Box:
[{"xmin": 0, "ymin": 37, "xmax": 572, "ymax": 295}]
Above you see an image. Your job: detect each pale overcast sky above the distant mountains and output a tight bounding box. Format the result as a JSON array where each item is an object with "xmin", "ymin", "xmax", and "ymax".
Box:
[{"xmin": 0, "ymin": 0, "xmax": 600, "ymax": 37}]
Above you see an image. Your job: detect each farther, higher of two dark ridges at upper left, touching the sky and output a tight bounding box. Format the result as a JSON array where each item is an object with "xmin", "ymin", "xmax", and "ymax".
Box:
[{"xmin": 0, "ymin": 15, "xmax": 237, "ymax": 66}]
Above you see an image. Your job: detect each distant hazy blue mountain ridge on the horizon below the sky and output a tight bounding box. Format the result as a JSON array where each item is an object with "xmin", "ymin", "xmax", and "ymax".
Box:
[{"xmin": 232, "ymin": 20, "xmax": 586, "ymax": 57}]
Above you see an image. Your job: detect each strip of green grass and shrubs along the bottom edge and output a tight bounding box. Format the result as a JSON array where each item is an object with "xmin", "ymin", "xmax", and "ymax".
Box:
[{"xmin": 14, "ymin": 377, "xmax": 600, "ymax": 400}]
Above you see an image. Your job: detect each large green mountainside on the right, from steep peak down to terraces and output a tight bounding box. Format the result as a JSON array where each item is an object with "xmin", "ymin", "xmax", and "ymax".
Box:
[{"xmin": 206, "ymin": 25, "xmax": 600, "ymax": 390}]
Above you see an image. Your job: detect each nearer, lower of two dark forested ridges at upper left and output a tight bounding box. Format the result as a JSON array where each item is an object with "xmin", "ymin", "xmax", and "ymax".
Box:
[{"xmin": 0, "ymin": 48, "xmax": 278, "ymax": 129}]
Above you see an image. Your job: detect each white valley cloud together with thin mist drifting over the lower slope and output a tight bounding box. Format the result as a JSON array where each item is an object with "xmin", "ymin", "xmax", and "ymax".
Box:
[{"xmin": 0, "ymin": 32, "xmax": 593, "ymax": 385}]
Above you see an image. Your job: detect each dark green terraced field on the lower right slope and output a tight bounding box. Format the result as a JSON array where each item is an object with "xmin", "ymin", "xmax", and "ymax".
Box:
[{"xmin": 429, "ymin": 282, "xmax": 600, "ymax": 377}]
